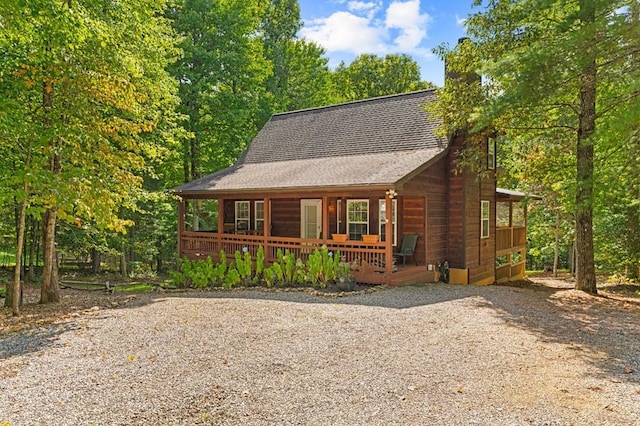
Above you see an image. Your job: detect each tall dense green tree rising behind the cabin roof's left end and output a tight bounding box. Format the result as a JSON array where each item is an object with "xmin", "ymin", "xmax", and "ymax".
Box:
[{"xmin": 169, "ymin": 0, "xmax": 271, "ymax": 182}]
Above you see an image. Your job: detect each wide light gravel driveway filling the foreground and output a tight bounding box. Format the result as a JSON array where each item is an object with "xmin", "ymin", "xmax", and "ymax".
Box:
[{"xmin": 0, "ymin": 284, "xmax": 640, "ymax": 426}]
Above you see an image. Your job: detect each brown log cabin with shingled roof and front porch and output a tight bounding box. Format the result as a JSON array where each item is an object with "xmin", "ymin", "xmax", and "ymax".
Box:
[{"xmin": 174, "ymin": 90, "xmax": 527, "ymax": 285}]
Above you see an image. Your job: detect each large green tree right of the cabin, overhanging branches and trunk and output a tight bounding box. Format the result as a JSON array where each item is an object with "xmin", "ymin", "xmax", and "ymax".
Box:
[{"xmin": 428, "ymin": 0, "xmax": 640, "ymax": 293}]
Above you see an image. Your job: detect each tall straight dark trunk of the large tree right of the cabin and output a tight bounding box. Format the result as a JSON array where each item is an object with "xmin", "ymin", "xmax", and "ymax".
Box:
[{"xmin": 575, "ymin": 0, "xmax": 598, "ymax": 294}]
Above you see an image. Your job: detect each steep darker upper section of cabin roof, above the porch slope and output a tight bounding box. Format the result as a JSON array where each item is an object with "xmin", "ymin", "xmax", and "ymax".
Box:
[{"xmin": 243, "ymin": 90, "xmax": 443, "ymax": 163}]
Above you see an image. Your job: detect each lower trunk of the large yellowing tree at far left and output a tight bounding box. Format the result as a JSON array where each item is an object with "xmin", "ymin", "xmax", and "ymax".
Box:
[{"xmin": 40, "ymin": 208, "xmax": 60, "ymax": 303}]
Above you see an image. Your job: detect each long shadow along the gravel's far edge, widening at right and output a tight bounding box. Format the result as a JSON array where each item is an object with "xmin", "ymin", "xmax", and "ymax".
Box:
[{"xmin": 167, "ymin": 282, "xmax": 640, "ymax": 383}]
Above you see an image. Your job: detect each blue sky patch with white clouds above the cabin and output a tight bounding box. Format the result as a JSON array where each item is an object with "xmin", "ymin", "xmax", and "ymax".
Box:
[{"xmin": 298, "ymin": 0, "xmax": 475, "ymax": 86}]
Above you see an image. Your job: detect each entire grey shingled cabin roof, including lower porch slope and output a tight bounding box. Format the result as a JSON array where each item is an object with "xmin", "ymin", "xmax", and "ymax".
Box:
[{"xmin": 175, "ymin": 90, "xmax": 447, "ymax": 195}]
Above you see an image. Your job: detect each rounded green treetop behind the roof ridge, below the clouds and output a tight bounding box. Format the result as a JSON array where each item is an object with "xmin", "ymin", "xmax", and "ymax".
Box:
[{"xmin": 334, "ymin": 54, "xmax": 433, "ymax": 101}]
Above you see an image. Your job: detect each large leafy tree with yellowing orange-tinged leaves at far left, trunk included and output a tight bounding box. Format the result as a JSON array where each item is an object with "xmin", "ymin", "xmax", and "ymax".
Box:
[{"xmin": 0, "ymin": 0, "xmax": 177, "ymax": 303}]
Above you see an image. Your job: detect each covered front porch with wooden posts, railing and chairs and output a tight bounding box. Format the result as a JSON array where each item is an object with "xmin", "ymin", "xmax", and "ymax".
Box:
[{"xmin": 178, "ymin": 189, "xmax": 434, "ymax": 285}]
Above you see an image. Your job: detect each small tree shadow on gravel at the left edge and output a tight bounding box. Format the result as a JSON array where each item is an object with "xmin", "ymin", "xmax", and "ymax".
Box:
[{"xmin": 0, "ymin": 322, "xmax": 77, "ymax": 361}]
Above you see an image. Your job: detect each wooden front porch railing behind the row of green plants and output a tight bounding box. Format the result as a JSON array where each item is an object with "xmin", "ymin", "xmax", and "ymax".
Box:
[{"xmin": 180, "ymin": 231, "xmax": 385, "ymax": 266}]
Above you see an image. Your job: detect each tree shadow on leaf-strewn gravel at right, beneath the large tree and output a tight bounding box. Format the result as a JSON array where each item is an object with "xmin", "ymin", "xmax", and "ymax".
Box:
[{"xmin": 482, "ymin": 285, "xmax": 640, "ymax": 383}]
